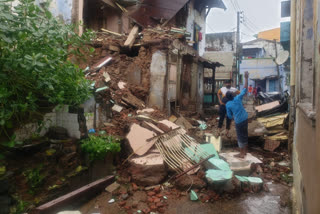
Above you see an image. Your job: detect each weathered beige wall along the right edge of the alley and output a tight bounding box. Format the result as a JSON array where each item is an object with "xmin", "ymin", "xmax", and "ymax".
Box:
[{"xmin": 291, "ymin": 0, "xmax": 320, "ymax": 214}]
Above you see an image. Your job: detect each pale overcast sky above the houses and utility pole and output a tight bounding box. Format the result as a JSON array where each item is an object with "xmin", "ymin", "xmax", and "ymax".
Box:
[{"xmin": 206, "ymin": 0, "xmax": 281, "ymax": 42}]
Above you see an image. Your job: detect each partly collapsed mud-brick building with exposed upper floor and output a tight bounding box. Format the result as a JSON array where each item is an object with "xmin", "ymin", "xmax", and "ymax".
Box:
[{"xmin": 79, "ymin": 1, "xmax": 225, "ymax": 129}]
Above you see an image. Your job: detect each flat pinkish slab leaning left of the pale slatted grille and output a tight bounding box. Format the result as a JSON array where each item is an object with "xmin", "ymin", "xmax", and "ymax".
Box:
[{"xmin": 127, "ymin": 124, "xmax": 156, "ymax": 156}]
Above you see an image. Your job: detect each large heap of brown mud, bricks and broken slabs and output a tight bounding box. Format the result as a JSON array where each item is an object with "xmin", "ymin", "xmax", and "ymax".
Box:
[{"xmin": 77, "ymin": 27, "xmax": 290, "ymax": 213}]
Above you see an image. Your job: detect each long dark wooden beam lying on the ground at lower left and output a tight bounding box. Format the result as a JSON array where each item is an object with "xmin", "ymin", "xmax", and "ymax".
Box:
[{"xmin": 31, "ymin": 176, "xmax": 115, "ymax": 214}]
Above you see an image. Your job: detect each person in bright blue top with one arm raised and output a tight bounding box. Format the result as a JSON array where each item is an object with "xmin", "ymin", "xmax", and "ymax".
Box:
[{"xmin": 226, "ymin": 72, "xmax": 249, "ymax": 158}]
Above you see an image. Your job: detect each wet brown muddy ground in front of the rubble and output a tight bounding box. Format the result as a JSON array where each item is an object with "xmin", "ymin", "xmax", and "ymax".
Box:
[{"xmin": 81, "ymin": 182, "xmax": 291, "ymax": 214}]
